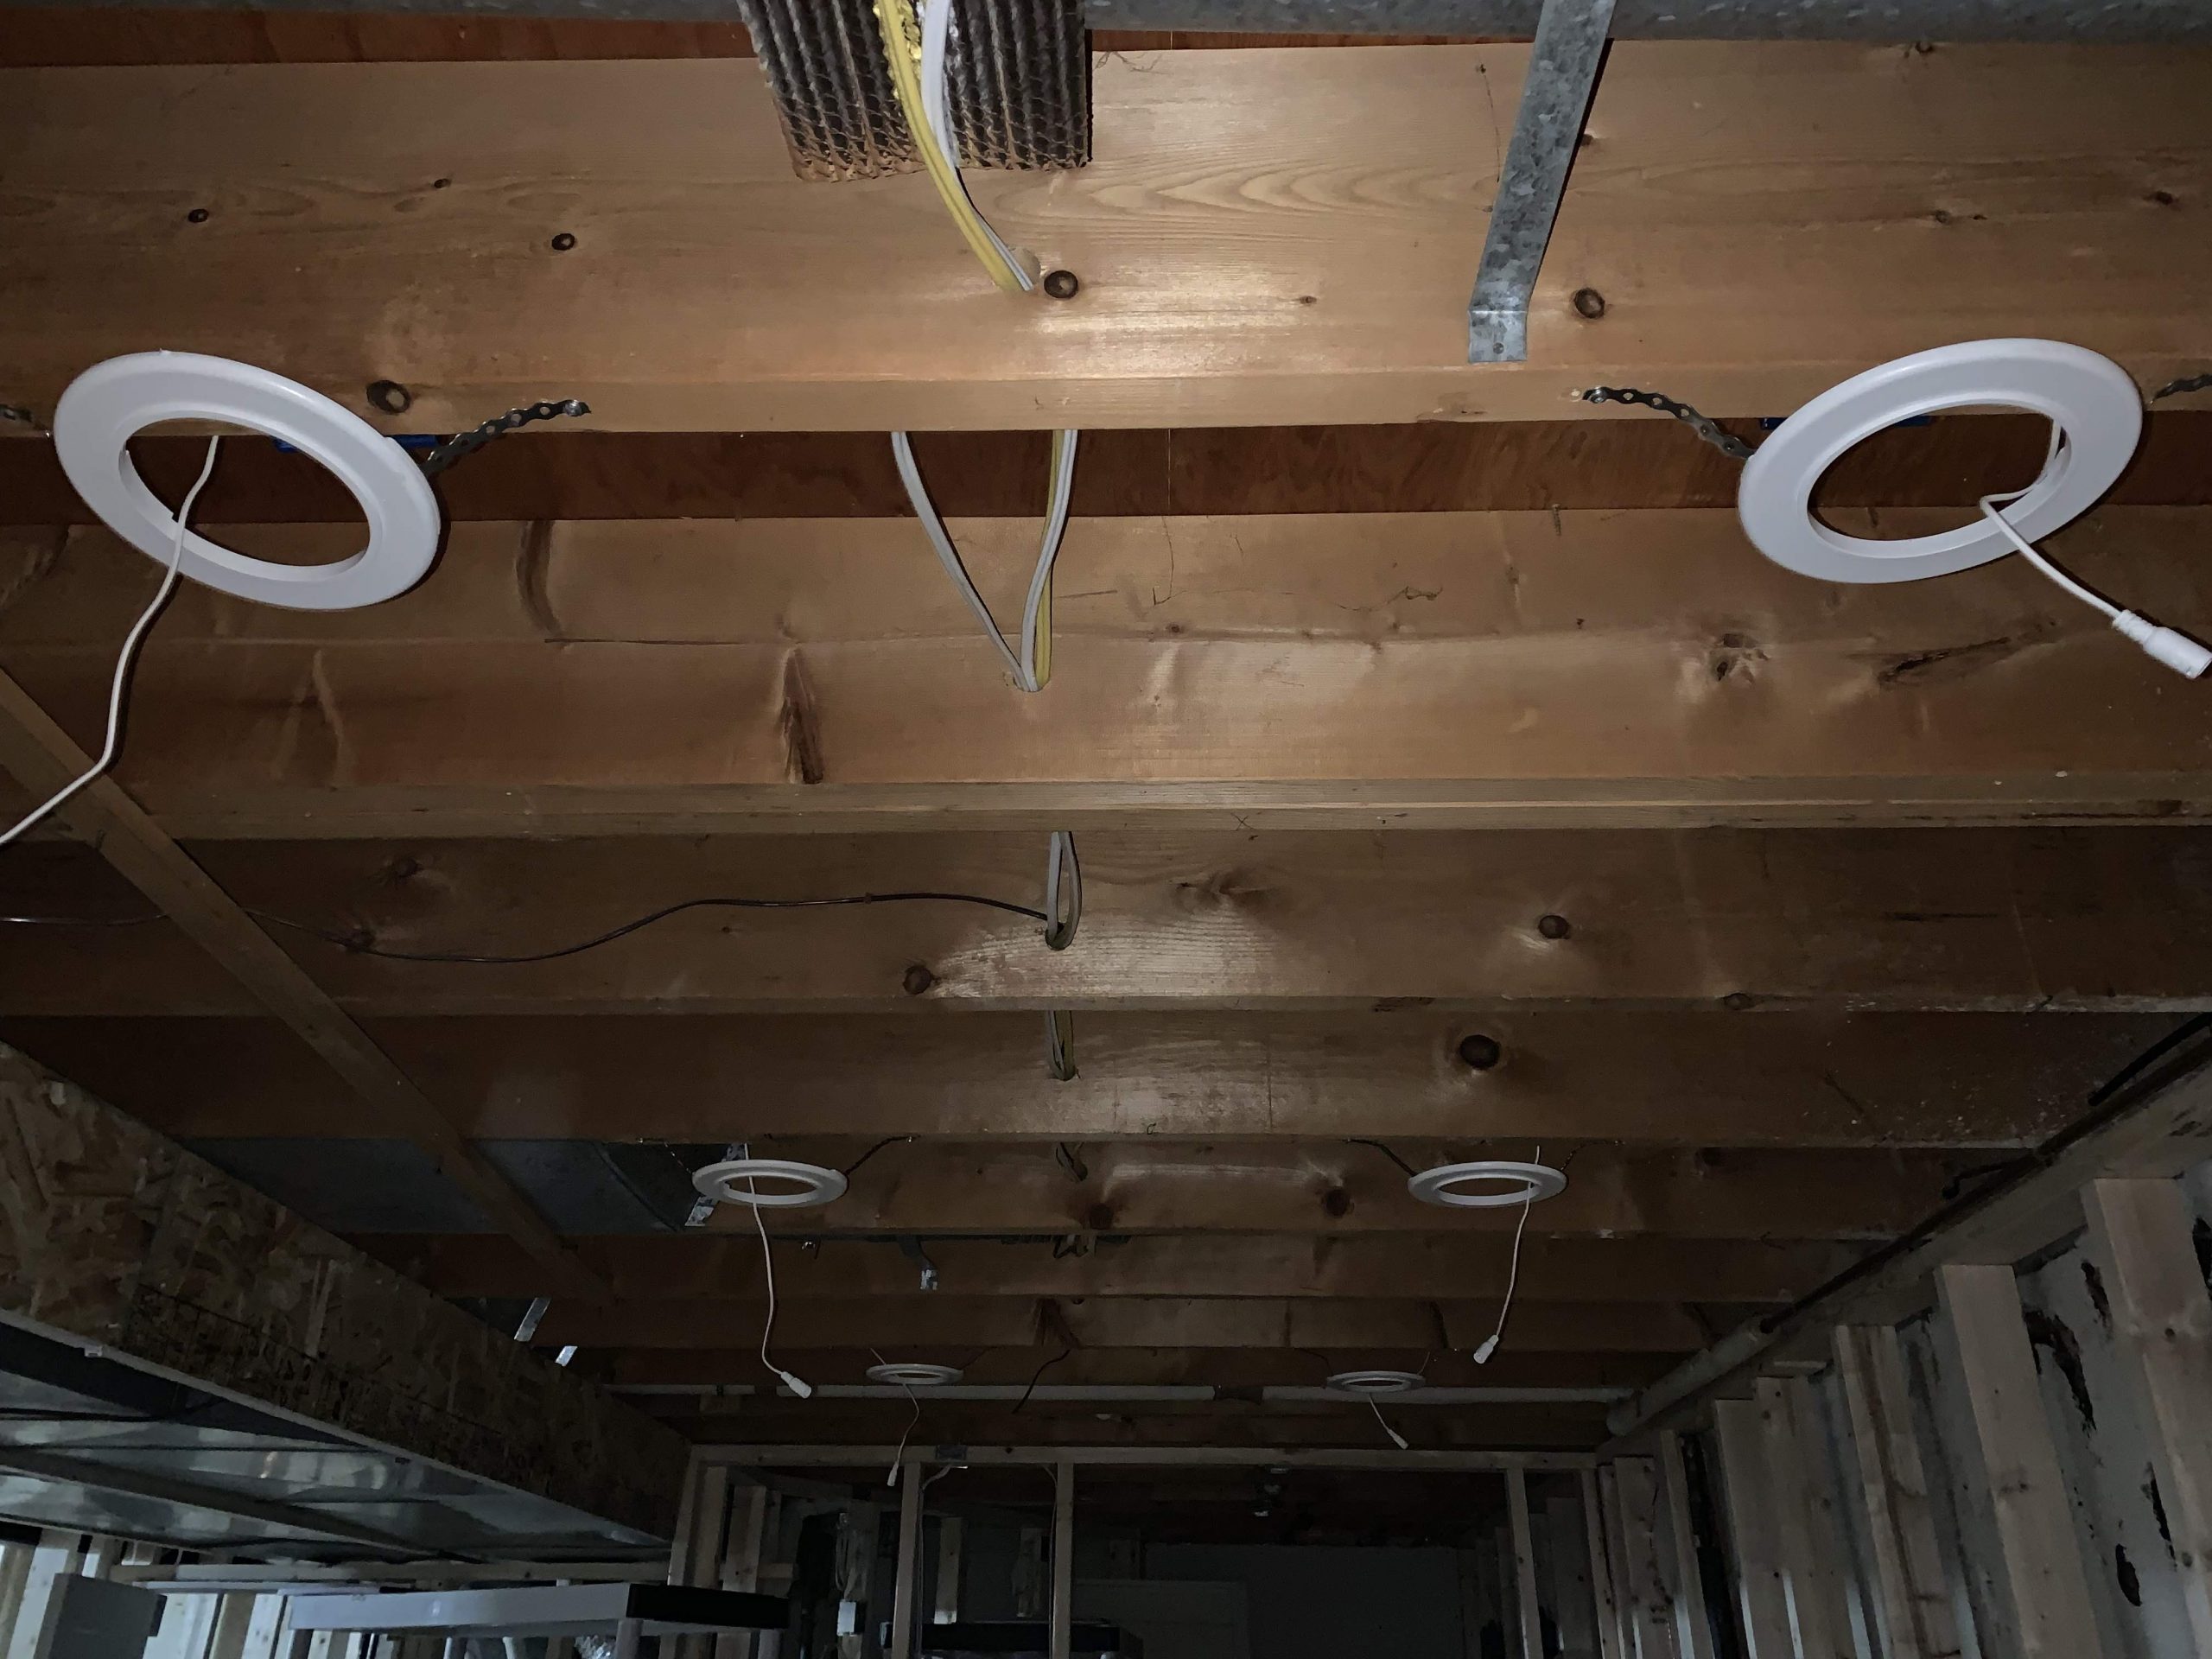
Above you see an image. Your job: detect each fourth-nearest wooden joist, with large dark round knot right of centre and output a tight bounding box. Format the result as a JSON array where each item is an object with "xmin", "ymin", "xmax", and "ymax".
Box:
[{"xmin": 17, "ymin": 1013, "xmax": 2172, "ymax": 1159}]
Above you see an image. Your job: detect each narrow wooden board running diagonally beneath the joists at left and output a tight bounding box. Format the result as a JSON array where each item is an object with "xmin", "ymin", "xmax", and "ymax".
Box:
[{"xmin": 0, "ymin": 672, "xmax": 600, "ymax": 1296}]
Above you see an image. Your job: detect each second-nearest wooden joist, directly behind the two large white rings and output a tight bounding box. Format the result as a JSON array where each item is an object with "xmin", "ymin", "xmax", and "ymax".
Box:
[{"xmin": 0, "ymin": 512, "xmax": 2212, "ymax": 841}]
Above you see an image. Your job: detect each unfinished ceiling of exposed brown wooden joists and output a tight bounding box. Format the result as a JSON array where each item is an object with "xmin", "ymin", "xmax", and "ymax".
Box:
[{"xmin": 0, "ymin": 0, "xmax": 2212, "ymax": 1541}]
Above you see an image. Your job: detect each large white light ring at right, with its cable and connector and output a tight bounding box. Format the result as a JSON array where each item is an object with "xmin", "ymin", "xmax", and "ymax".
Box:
[{"xmin": 1737, "ymin": 339, "xmax": 2212, "ymax": 679}]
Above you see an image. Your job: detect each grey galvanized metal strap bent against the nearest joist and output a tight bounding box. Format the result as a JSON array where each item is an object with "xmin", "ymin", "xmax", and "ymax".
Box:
[{"xmin": 1466, "ymin": 0, "xmax": 1612, "ymax": 363}]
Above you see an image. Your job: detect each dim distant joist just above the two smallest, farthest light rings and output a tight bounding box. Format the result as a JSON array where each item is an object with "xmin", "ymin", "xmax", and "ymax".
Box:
[{"xmin": 537, "ymin": 1289, "xmax": 1714, "ymax": 1370}]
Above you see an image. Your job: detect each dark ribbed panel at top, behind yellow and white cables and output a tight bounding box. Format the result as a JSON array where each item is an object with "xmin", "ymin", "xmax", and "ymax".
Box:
[{"xmin": 739, "ymin": 0, "xmax": 1090, "ymax": 179}]
